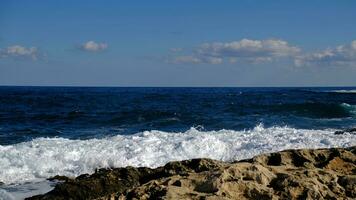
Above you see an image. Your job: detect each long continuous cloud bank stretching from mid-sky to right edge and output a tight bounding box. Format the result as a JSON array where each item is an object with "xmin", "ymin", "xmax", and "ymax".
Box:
[{"xmin": 169, "ymin": 39, "xmax": 356, "ymax": 67}]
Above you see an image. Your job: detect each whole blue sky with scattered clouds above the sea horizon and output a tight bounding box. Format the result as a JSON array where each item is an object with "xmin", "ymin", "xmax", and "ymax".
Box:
[{"xmin": 0, "ymin": 0, "xmax": 356, "ymax": 87}]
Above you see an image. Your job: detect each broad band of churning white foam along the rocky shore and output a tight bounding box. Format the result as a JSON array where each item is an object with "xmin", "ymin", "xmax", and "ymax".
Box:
[{"xmin": 0, "ymin": 125, "xmax": 356, "ymax": 184}]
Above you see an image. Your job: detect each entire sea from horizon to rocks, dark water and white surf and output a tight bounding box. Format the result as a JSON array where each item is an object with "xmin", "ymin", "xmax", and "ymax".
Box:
[{"xmin": 0, "ymin": 87, "xmax": 356, "ymax": 199}]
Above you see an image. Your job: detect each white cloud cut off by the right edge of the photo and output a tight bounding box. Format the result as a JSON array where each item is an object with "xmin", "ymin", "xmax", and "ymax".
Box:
[{"xmin": 294, "ymin": 40, "xmax": 356, "ymax": 66}]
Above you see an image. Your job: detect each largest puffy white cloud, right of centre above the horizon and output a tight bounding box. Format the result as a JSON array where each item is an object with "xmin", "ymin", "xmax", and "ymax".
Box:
[{"xmin": 174, "ymin": 39, "xmax": 300, "ymax": 64}]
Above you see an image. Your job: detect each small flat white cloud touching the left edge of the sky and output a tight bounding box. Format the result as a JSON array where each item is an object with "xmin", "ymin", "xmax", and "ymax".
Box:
[{"xmin": 0, "ymin": 45, "xmax": 38, "ymax": 60}]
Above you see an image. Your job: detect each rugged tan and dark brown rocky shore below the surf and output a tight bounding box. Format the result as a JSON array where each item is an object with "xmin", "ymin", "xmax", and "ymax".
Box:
[{"xmin": 28, "ymin": 147, "xmax": 356, "ymax": 200}]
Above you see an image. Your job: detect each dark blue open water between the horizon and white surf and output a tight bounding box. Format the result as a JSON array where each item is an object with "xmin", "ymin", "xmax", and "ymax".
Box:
[{"xmin": 0, "ymin": 87, "xmax": 356, "ymax": 145}]
